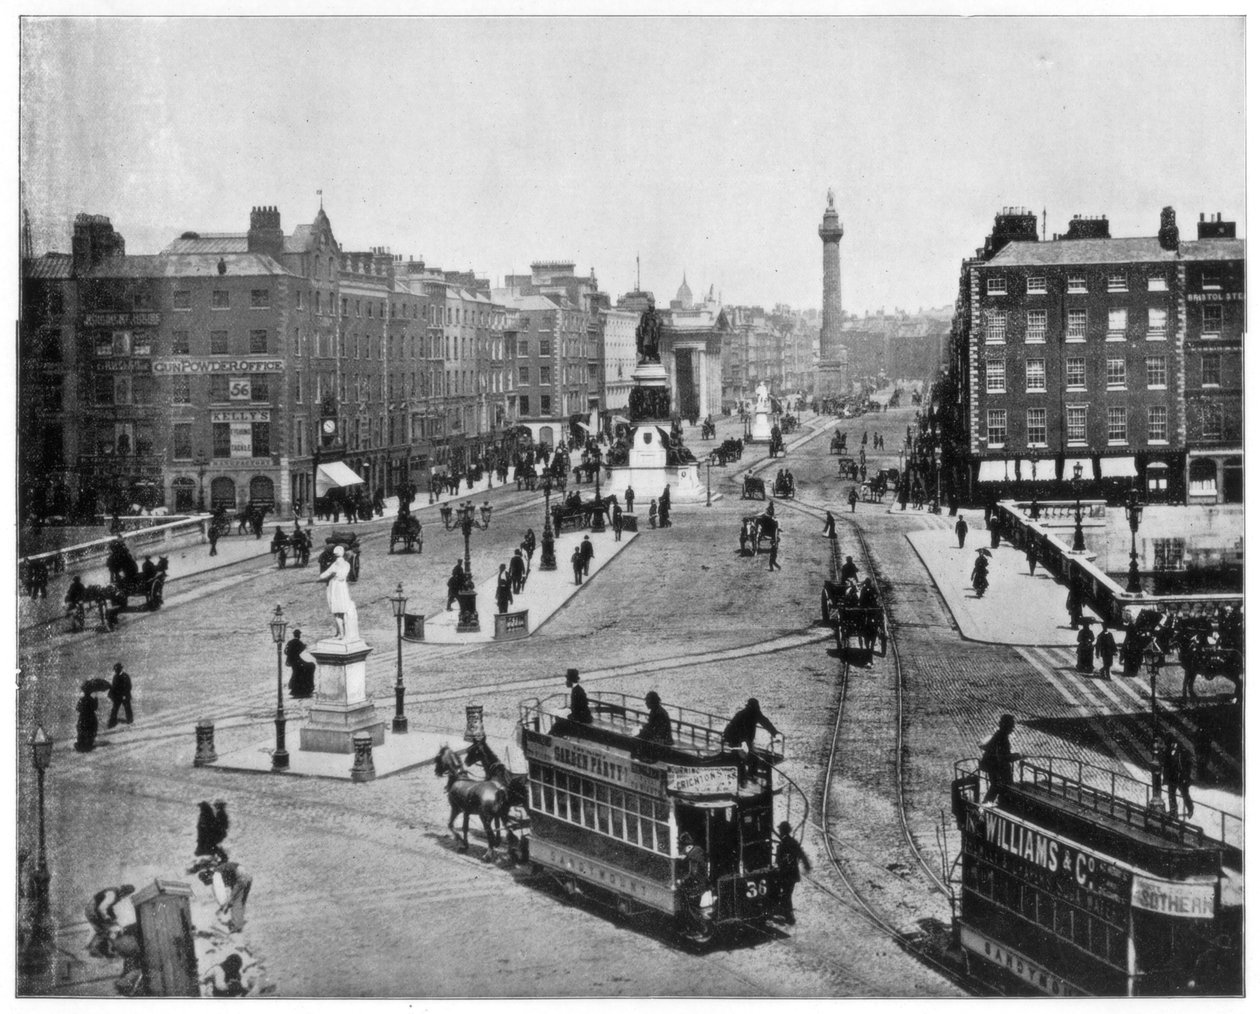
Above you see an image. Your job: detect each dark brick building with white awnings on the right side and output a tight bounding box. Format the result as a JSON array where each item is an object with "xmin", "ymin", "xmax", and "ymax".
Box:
[{"xmin": 942, "ymin": 208, "xmax": 1245, "ymax": 503}]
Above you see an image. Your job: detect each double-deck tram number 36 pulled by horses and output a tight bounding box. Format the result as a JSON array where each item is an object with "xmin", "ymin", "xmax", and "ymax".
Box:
[{"xmin": 520, "ymin": 693, "xmax": 785, "ymax": 941}]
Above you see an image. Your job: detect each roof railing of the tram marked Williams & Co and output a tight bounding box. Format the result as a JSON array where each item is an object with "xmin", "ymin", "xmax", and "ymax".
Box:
[{"xmin": 954, "ymin": 756, "xmax": 1244, "ymax": 850}]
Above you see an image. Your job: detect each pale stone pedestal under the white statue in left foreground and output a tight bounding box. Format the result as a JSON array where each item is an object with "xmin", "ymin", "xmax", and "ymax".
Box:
[{"xmin": 299, "ymin": 637, "xmax": 386, "ymax": 753}]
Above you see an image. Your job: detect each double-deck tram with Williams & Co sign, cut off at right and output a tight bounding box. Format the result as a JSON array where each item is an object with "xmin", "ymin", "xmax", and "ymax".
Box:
[{"xmin": 953, "ymin": 758, "xmax": 1242, "ymax": 996}]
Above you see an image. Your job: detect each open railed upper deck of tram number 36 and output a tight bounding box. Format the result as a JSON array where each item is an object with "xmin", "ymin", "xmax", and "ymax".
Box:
[{"xmin": 520, "ymin": 692, "xmax": 785, "ymax": 767}]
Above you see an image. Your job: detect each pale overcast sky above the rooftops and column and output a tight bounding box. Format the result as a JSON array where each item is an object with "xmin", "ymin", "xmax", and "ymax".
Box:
[{"xmin": 20, "ymin": 18, "xmax": 1245, "ymax": 312}]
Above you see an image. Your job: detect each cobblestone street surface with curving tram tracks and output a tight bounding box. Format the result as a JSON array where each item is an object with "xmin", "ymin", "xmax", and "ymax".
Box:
[{"xmin": 19, "ymin": 409, "xmax": 1241, "ymax": 996}]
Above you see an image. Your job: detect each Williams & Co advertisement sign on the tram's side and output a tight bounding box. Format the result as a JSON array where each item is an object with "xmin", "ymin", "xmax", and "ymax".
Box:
[{"xmin": 969, "ymin": 810, "xmax": 1131, "ymax": 906}]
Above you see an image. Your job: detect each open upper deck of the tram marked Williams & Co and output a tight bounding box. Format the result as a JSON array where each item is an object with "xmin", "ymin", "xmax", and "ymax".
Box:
[{"xmin": 955, "ymin": 757, "xmax": 1244, "ymax": 878}]
